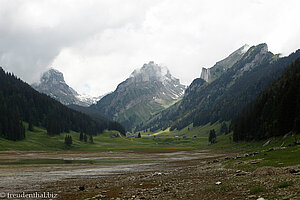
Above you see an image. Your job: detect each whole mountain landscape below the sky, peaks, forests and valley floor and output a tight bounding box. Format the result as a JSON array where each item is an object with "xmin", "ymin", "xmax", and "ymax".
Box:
[{"xmin": 0, "ymin": 44, "xmax": 300, "ymax": 200}]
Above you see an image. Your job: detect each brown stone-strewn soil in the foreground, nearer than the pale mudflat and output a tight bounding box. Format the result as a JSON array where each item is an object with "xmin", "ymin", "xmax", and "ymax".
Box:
[{"xmin": 39, "ymin": 151, "xmax": 300, "ymax": 200}]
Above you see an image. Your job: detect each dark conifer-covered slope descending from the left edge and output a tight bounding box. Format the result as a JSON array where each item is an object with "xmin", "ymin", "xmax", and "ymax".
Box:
[{"xmin": 0, "ymin": 68, "xmax": 124, "ymax": 140}]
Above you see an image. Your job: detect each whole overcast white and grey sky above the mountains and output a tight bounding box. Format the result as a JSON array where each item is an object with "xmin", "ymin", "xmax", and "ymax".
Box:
[{"xmin": 0, "ymin": 0, "xmax": 300, "ymax": 96}]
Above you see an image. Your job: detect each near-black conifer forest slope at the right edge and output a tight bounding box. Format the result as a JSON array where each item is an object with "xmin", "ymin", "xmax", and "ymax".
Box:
[{"xmin": 232, "ymin": 55, "xmax": 300, "ymax": 141}]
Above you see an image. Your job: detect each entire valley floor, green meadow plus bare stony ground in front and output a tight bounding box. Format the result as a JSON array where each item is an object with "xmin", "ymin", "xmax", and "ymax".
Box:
[{"xmin": 0, "ymin": 124, "xmax": 300, "ymax": 200}]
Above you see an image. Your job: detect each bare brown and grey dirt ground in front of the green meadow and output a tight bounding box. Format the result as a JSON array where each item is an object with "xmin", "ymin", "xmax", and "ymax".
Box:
[{"xmin": 0, "ymin": 151, "xmax": 300, "ymax": 200}]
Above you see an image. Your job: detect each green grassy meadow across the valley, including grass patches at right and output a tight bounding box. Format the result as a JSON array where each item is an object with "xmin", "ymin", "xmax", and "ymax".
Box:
[{"xmin": 0, "ymin": 123, "xmax": 300, "ymax": 165}]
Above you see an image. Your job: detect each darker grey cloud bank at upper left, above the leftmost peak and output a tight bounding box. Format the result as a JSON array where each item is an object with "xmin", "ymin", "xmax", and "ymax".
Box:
[{"xmin": 0, "ymin": 0, "xmax": 158, "ymax": 83}]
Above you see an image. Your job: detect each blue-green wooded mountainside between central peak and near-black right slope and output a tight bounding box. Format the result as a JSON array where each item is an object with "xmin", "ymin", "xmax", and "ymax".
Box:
[{"xmin": 139, "ymin": 44, "xmax": 300, "ymax": 131}]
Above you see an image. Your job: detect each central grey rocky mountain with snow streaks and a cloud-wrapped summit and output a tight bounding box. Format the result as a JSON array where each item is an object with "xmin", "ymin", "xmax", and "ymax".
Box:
[{"xmin": 92, "ymin": 61, "xmax": 185, "ymax": 128}]
